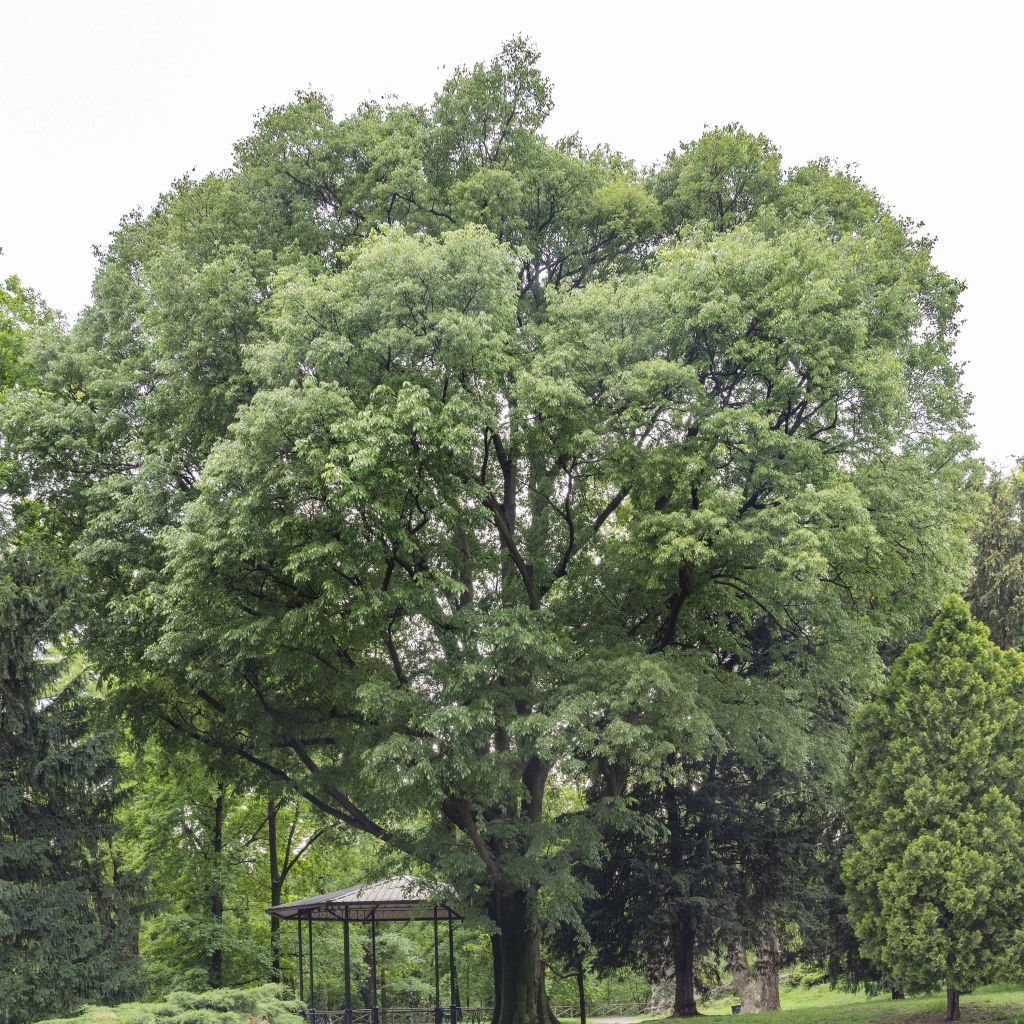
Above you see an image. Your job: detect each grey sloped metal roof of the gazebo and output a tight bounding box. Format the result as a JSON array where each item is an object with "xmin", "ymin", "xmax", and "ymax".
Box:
[{"xmin": 266, "ymin": 874, "xmax": 462, "ymax": 921}]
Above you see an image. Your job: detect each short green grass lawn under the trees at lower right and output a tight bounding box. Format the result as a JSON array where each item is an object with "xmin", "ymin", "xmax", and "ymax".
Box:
[{"xmin": 659, "ymin": 985, "xmax": 1024, "ymax": 1024}]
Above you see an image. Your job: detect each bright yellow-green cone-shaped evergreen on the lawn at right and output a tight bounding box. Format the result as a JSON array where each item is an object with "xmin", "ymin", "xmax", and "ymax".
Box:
[{"xmin": 843, "ymin": 597, "xmax": 1024, "ymax": 1020}]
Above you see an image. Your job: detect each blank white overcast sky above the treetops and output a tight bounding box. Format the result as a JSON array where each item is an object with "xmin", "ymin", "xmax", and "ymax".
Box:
[{"xmin": 0, "ymin": 0, "xmax": 1024, "ymax": 463}]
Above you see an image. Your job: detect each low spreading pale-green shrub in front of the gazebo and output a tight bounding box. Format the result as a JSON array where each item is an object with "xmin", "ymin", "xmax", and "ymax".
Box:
[{"xmin": 38, "ymin": 985, "xmax": 302, "ymax": 1024}]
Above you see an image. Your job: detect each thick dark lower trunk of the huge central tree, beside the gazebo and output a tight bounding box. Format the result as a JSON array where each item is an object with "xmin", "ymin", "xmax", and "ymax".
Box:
[{"xmin": 490, "ymin": 889, "xmax": 556, "ymax": 1024}]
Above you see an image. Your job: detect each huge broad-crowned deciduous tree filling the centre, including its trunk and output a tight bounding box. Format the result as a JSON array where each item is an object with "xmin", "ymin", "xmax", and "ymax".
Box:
[{"xmin": 3, "ymin": 41, "xmax": 971, "ymax": 1024}]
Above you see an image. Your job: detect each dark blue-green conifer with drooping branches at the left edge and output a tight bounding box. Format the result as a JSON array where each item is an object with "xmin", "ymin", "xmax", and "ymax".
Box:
[{"xmin": 0, "ymin": 531, "xmax": 137, "ymax": 1024}]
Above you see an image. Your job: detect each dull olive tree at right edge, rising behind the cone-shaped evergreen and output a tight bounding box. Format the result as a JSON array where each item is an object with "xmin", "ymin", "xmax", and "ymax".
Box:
[{"xmin": 968, "ymin": 461, "xmax": 1024, "ymax": 649}]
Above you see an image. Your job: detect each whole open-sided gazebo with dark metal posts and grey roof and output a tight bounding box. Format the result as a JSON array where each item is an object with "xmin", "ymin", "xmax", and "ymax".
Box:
[{"xmin": 266, "ymin": 876, "xmax": 475, "ymax": 1024}]
